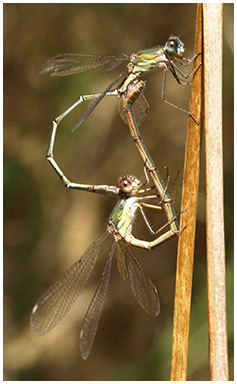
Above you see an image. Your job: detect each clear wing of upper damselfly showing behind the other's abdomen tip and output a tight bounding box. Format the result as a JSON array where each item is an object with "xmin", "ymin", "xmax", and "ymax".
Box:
[{"xmin": 118, "ymin": 93, "xmax": 150, "ymax": 127}]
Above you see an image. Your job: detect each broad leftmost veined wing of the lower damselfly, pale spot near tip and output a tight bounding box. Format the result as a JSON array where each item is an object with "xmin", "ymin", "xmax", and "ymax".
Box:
[{"xmin": 31, "ymin": 231, "xmax": 108, "ymax": 336}]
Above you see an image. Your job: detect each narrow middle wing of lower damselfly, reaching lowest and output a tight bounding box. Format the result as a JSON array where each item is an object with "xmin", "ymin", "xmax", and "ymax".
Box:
[{"xmin": 79, "ymin": 242, "xmax": 115, "ymax": 359}]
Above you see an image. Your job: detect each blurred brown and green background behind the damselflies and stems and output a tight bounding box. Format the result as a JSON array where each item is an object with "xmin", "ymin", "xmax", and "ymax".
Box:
[{"xmin": 4, "ymin": 3, "xmax": 234, "ymax": 381}]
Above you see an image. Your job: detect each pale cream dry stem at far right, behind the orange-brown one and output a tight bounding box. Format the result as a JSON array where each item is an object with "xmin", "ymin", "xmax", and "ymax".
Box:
[{"xmin": 203, "ymin": 3, "xmax": 228, "ymax": 381}]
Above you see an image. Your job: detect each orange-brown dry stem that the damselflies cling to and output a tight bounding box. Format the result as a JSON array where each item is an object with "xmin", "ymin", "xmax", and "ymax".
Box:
[{"xmin": 170, "ymin": 4, "xmax": 202, "ymax": 381}]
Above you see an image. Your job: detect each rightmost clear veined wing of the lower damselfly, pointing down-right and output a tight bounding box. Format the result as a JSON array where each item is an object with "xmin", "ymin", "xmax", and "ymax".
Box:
[{"xmin": 115, "ymin": 240, "xmax": 160, "ymax": 316}]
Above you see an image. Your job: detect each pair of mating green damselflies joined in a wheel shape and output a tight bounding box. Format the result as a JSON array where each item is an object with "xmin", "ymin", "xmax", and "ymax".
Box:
[{"xmin": 31, "ymin": 36, "xmax": 200, "ymax": 359}]
